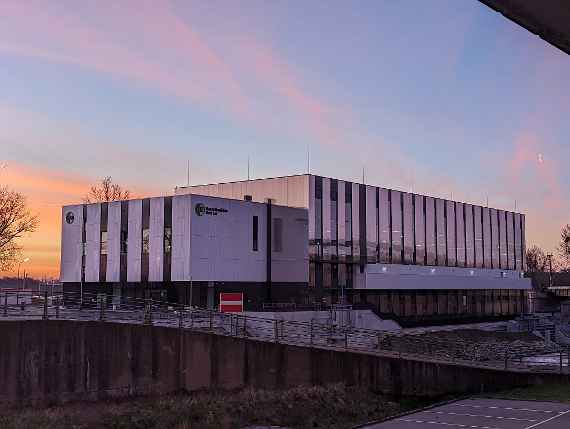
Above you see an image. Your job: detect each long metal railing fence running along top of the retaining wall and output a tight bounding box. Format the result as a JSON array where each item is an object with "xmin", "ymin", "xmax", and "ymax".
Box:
[{"xmin": 4, "ymin": 291, "xmax": 570, "ymax": 374}]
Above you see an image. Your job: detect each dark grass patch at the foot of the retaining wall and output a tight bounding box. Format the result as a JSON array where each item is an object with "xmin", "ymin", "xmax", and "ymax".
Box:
[{"xmin": 0, "ymin": 385, "xmax": 425, "ymax": 429}]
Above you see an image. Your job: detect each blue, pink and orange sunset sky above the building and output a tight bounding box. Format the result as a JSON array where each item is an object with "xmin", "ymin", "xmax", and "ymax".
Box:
[{"xmin": 0, "ymin": 0, "xmax": 570, "ymax": 277}]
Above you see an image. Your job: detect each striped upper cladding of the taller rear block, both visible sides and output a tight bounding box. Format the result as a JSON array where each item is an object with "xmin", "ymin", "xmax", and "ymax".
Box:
[{"xmin": 176, "ymin": 174, "xmax": 528, "ymax": 288}]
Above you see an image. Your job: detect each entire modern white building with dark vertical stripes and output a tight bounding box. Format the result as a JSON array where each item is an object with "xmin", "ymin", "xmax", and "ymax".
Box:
[{"xmin": 61, "ymin": 174, "xmax": 531, "ymax": 321}]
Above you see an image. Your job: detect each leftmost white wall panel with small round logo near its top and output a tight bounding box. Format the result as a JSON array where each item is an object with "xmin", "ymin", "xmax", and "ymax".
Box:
[{"xmin": 60, "ymin": 205, "xmax": 83, "ymax": 282}]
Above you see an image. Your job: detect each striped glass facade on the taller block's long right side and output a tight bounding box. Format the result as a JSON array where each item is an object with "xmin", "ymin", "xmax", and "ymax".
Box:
[{"xmin": 306, "ymin": 177, "xmax": 524, "ymax": 274}]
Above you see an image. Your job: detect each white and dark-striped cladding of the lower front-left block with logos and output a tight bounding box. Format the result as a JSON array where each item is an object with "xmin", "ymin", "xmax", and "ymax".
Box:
[{"xmin": 61, "ymin": 195, "xmax": 309, "ymax": 284}]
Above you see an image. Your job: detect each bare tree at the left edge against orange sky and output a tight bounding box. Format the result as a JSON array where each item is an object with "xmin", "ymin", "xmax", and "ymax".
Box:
[{"xmin": 0, "ymin": 187, "xmax": 39, "ymax": 271}]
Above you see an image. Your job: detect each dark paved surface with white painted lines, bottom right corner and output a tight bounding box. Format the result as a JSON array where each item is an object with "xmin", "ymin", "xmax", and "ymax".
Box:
[{"xmin": 366, "ymin": 399, "xmax": 570, "ymax": 429}]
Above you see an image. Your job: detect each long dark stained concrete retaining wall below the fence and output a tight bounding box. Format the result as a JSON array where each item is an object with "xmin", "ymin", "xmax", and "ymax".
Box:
[{"xmin": 0, "ymin": 320, "xmax": 561, "ymax": 403}]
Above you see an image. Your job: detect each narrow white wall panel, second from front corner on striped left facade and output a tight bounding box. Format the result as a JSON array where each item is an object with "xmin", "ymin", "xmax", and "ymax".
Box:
[{"xmin": 148, "ymin": 197, "xmax": 164, "ymax": 282}]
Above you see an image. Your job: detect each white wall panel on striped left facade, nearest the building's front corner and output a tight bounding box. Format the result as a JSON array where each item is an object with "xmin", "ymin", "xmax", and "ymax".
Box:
[{"xmin": 171, "ymin": 195, "xmax": 191, "ymax": 281}]
